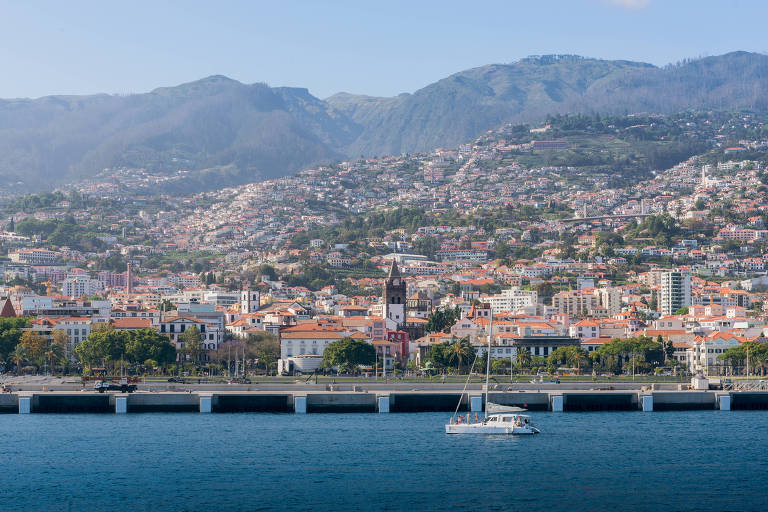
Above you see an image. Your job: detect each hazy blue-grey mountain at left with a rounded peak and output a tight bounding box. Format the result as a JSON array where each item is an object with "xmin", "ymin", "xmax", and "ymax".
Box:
[{"xmin": 0, "ymin": 76, "xmax": 360, "ymax": 193}]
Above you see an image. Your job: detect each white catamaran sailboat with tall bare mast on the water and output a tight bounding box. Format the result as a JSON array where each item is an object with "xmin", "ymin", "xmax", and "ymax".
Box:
[{"xmin": 445, "ymin": 310, "xmax": 540, "ymax": 436}]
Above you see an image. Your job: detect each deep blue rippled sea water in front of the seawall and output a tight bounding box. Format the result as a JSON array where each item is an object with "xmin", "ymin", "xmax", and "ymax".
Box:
[{"xmin": 0, "ymin": 411, "xmax": 768, "ymax": 512}]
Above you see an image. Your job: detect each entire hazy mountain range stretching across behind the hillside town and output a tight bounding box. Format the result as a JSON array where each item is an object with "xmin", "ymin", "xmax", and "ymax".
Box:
[{"xmin": 0, "ymin": 52, "xmax": 768, "ymax": 191}]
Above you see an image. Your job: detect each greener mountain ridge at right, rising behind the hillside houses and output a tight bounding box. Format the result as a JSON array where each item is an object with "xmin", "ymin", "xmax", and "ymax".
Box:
[{"xmin": 326, "ymin": 52, "xmax": 768, "ymax": 155}]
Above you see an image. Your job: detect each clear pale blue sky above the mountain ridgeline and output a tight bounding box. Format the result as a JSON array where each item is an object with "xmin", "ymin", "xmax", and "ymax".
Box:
[{"xmin": 0, "ymin": 0, "xmax": 768, "ymax": 98}]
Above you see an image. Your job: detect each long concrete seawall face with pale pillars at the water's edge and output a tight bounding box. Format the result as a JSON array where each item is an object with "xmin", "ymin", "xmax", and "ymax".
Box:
[{"xmin": 0, "ymin": 387, "xmax": 768, "ymax": 413}]
